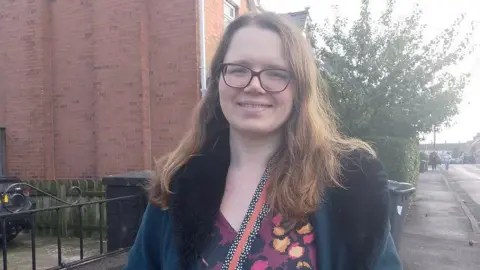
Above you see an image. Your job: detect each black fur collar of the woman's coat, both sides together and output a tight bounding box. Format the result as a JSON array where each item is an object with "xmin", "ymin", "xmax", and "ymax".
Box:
[{"xmin": 169, "ymin": 132, "xmax": 388, "ymax": 269}]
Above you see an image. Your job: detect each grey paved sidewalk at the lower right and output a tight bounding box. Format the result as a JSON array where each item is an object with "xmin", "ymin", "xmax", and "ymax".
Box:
[{"xmin": 400, "ymin": 171, "xmax": 480, "ymax": 270}]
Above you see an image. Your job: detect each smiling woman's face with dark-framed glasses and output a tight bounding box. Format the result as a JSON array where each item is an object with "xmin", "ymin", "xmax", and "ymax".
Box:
[{"xmin": 218, "ymin": 26, "xmax": 294, "ymax": 135}]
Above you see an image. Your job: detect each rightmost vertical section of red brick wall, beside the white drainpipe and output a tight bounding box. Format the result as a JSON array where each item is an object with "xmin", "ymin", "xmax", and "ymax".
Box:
[{"xmin": 149, "ymin": 0, "xmax": 200, "ymax": 158}]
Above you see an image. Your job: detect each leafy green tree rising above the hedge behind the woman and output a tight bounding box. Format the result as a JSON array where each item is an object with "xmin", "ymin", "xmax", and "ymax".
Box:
[{"xmin": 306, "ymin": 0, "xmax": 474, "ymax": 137}]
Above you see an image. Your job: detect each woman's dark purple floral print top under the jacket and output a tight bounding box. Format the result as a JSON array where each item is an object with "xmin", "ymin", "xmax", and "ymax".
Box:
[{"xmin": 202, "ymin": 213, "xmax": 316, "ymax": 270}]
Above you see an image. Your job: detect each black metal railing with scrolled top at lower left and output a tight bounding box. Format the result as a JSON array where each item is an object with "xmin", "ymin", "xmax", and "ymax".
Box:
[{"xmin": 0, "ymin": 183, "xmax": 142, "ymax": 270}]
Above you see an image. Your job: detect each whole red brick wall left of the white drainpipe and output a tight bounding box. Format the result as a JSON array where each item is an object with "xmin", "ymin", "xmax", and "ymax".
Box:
[{"xmin": 0, "ymin": 0, "xmax": 199, "ymax": 179}]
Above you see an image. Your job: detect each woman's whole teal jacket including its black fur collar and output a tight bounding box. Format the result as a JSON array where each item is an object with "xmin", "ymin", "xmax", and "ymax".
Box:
[{"xmin": 124, "ymin": 132, "xmax": 403, "ymax": 270}]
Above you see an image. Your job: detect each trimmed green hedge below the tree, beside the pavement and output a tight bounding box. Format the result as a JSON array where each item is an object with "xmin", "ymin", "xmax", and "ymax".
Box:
[{"xmin": 363, "ymin": 137, "xmax": 420, "ymax": 185}]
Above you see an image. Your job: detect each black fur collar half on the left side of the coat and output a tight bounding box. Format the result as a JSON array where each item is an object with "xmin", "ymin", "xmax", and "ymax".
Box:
[{"xmin": 169, "ymin": 133, "xmax": 230, "ymax": 269}]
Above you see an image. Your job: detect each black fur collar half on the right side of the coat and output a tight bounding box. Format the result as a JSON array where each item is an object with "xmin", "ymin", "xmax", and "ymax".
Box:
[{"xmin": 327, "ymin": 150, "xmax": 389, "ymax": 265}]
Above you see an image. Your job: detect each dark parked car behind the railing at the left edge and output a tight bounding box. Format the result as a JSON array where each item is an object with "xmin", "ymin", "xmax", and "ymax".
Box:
[{"xmin": 0, "ymin": 177, "xmax": 35, "ymax": 243}]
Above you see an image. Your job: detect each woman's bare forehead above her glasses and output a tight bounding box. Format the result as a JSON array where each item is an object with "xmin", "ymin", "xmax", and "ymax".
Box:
[{"xmin": 224, "ymin": 26, "xmax": 288, "ymax": 68}]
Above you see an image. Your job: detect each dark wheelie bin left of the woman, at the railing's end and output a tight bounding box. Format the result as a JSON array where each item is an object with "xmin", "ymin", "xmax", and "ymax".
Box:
[{"xmin": 102, "ymin": 171, "xmax": 152, "ymax": 252}]
